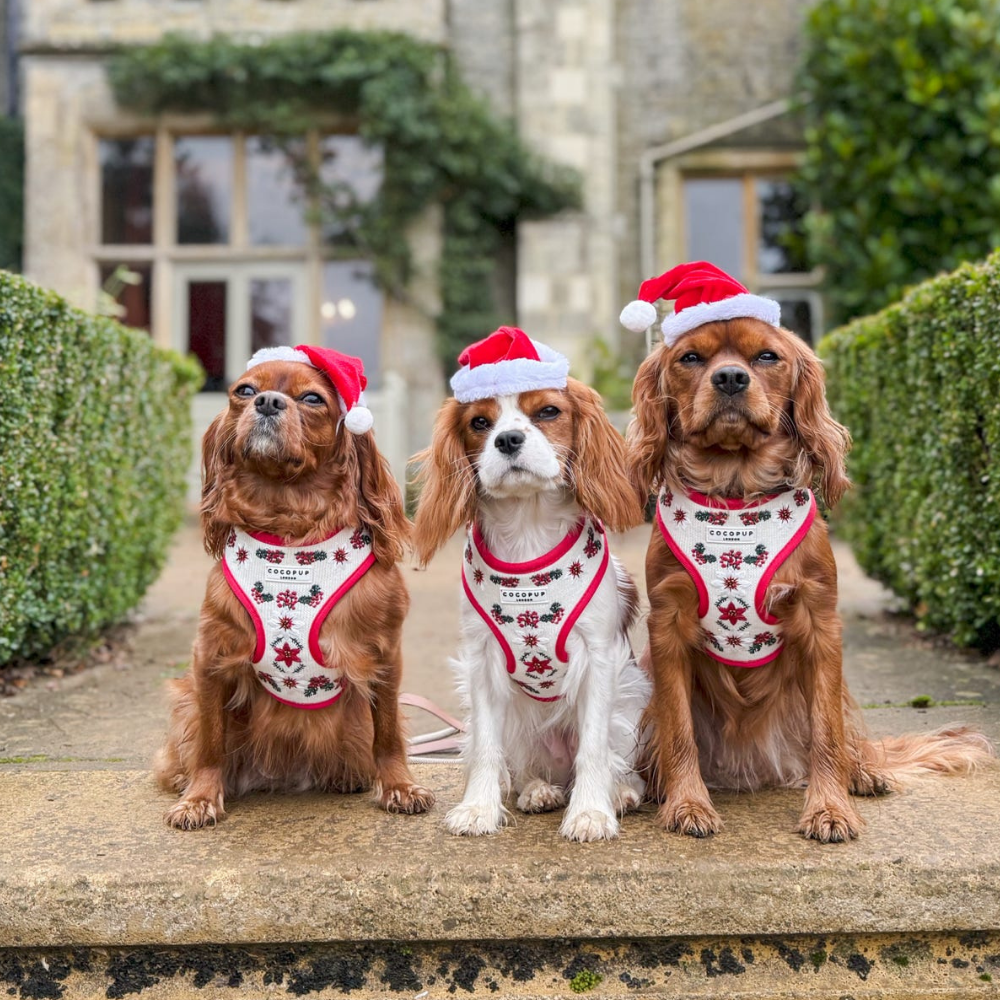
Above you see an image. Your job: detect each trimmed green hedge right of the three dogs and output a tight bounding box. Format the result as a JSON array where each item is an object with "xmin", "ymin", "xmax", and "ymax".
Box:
[{"xmin": 820, "ymin": 254, "xmax": 1000, "ymax": 650}]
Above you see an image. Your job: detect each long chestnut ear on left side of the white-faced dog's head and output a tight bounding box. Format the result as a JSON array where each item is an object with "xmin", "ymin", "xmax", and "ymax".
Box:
[{"xmin": 413, "ymin": 399, "xmax": 476, "ymax": 566}]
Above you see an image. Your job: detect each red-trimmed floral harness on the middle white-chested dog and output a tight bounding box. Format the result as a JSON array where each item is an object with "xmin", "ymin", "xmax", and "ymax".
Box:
[{"xmin": 462, "ymin": 517, "xmax": 609, "ymax": 701}]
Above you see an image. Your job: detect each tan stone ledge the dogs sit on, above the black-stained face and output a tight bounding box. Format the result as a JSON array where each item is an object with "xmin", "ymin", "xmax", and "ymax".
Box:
[{"xmin": 0, "ymin": 710, "xmax": 1000, "ymax": 948}]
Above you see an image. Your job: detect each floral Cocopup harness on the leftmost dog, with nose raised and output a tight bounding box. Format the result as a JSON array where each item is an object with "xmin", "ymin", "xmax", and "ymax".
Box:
[{"xmin": 222, "ymin": 528, "xmax": 375, "ymax": 708}]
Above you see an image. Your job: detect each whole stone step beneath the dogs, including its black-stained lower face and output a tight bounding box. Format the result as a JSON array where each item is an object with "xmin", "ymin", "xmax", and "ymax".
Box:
[{"xmin": 0, "ymin": 740, "xmax": 1000, "ymax": 1000}]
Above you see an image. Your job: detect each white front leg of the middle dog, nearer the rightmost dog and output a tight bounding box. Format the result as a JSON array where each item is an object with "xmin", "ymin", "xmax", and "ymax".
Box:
[{"xmin": 559, "ymin": 643, "xmax": 629, "ymax": 841}]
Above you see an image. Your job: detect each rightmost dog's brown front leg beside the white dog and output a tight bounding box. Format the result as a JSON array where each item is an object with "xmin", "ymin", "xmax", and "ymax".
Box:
[{"xmin": 647, "ymin": 573, "xmax": 722, "ymax": 837}]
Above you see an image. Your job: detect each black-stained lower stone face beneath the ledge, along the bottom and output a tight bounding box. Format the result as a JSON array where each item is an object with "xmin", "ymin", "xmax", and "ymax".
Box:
[{"xmin": 0, "ymin": 933, "xmax": 1000, "ymax": 1000}]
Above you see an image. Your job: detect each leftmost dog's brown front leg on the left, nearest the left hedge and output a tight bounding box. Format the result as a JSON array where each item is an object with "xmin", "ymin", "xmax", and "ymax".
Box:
[{"xmin": 164, "ymin": 664, "xmax": 230, "ymax": 830}]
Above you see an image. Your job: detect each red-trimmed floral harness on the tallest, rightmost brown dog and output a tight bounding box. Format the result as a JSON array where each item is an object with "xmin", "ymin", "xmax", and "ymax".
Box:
[{"xmin": 656, "ymin": 488, "xmax": 816, "ymax": 667}]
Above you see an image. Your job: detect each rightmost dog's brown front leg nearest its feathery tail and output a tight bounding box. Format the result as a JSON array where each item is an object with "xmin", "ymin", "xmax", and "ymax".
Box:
[{"xmin": 782, "ymin": 581, "xmax": 862, "ymax": 844}]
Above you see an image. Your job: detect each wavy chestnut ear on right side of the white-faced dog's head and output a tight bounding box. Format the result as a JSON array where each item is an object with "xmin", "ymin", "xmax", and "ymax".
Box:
[{"xmin": 566, "ymin": 378, "xmax": 642, "ymax": 531}]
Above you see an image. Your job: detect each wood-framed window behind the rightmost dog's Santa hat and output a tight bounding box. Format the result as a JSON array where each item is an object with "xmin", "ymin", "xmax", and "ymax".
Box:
[{"xmin": 683, "ymin": 171, "xmax": 823, "ymax": 343}]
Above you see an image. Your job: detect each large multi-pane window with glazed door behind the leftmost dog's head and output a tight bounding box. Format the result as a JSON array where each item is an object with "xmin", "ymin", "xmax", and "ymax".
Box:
[{"xmin": 94, "ymin": 129, "xmax": 383, "ymax": 391}]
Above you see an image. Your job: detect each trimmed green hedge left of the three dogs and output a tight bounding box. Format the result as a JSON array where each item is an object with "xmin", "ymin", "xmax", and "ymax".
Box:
[{"xmin": 0, "ymin": 271, "xmax": 202, "ymax": 664}]
